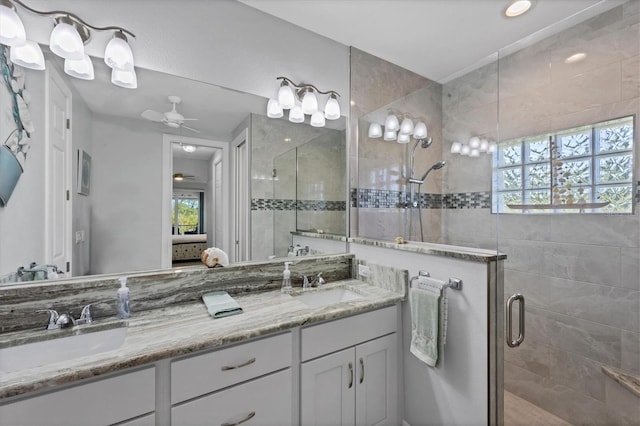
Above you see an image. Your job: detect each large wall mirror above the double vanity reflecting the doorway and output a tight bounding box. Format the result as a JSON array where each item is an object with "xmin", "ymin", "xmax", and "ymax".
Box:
[{"xmin": 0, "ymin": 42, "xmax": 346, "ymax": 283}]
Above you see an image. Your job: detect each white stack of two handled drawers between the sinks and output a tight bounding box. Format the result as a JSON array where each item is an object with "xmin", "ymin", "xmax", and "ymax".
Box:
[{"xmin": 171, "ymin": 333, "xmax": 293, "ymax": 426}]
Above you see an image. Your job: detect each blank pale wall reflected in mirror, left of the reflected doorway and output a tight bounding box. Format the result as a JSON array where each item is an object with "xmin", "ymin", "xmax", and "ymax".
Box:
[{"xmin": 90, "ymin": 116, "xmax": 165, "ymax": 274}]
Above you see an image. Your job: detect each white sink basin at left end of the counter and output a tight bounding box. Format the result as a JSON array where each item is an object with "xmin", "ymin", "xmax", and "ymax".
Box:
[{"xmin": 0, "ymin": 327, "xmax": 127, "ymax": 373}]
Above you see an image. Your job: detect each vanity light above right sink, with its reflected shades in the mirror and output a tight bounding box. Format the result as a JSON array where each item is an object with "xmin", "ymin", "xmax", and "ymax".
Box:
[{"xmin": 267, "ymin": 77, "xmax": 340, "ymax": 127}]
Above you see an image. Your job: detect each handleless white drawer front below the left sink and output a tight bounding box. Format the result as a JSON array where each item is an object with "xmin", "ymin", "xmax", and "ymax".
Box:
[{"xmin": 0, "ymin": 368, "xmax": 156, "ymax": 426}]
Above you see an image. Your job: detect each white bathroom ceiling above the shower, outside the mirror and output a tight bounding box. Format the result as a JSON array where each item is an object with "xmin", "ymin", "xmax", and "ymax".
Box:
[{"xmin": 240, "ymin": 0, "xmax": 623, "ymax": 82}]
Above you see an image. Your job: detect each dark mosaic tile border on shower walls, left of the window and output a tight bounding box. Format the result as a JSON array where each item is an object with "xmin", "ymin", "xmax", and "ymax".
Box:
[{"xmin": 350, "ymin": 188, "xmax": 491, "ymax": 209}]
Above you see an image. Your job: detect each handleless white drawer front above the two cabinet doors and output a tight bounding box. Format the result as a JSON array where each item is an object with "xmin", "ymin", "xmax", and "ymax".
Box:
[{"xmin": 302, "ymin": 306, "xmax": 398, "ymax": 361}]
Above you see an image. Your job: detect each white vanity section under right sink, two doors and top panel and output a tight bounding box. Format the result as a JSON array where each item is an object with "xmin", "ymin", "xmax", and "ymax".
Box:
[{"xmin": 300, "ymin": 307, "xmax": 399, "ymax": 426}]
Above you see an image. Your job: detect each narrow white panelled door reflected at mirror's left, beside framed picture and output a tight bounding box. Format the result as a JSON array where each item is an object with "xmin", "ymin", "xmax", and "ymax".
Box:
[{"xmin": 45, "ymin": 67, "xmax": 72, "ymax": 276}]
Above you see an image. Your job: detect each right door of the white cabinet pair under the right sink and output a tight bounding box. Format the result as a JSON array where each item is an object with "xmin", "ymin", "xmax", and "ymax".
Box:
[{"xmin": 356, "ymin": 333, "xmax": 398, "ymax": 426}]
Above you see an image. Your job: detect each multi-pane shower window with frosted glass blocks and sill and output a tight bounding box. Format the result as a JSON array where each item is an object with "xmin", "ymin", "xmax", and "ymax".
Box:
[{"xmin": 492, "ymin": 116, "xmax": 634, "ymax": 213}]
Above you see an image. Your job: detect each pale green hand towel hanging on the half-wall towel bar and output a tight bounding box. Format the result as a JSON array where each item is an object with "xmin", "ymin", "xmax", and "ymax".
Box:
[{"xmin": 409, "ymin": 277, "xmax": 447, "ymax": 367}]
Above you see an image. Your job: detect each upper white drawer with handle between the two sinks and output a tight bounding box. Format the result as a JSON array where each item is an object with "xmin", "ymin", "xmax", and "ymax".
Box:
[{"xmin": 171, "ymin": 333, "xmax": 292, "ymax": 404}]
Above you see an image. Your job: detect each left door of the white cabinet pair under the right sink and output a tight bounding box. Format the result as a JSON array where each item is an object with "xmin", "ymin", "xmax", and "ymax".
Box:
[{"xmin": 300, "ymin": 348, "xmax": 356, "ymax": 426}]
